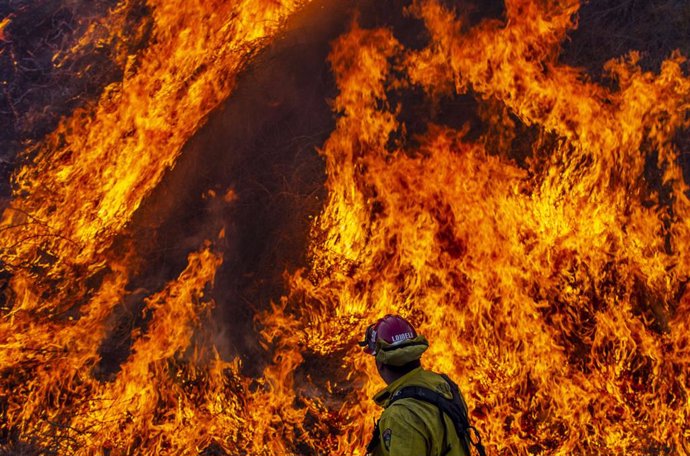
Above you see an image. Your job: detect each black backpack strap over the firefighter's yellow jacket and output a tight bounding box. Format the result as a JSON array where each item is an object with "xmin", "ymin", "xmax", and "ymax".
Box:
[{"xmin": 389, "ymin": 375, "xmax": 486, "ymax": 456}]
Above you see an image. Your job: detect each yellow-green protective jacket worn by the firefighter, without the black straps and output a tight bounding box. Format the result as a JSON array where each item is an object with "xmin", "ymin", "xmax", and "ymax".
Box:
[{"xmin": 371, "ymin": 367, "xmax": 470, "ymax": 456}]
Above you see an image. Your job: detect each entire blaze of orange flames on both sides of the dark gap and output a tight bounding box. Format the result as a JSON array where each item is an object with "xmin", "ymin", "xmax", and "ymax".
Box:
[{"xmin": 0, "ymin": 0, "xmax": 690, "ymax": 455}]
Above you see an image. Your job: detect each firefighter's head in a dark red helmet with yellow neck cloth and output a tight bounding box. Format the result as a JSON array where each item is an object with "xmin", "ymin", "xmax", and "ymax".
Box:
[{"xmin": 359, "ymin": 315, "xmax": 429, "ymax": 383}]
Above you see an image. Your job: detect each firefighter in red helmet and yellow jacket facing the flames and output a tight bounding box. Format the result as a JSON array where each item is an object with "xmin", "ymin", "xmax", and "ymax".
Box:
[{"xmin": 360, "ymin": 315, "xmax": 484, "ymax": 456}]
